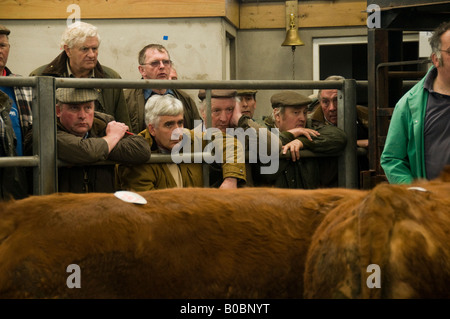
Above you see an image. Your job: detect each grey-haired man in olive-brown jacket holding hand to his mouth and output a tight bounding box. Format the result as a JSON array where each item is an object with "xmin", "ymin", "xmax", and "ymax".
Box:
[{"xmin": 117, "ymin": 95, "xmax": 246, "ymax": 191}]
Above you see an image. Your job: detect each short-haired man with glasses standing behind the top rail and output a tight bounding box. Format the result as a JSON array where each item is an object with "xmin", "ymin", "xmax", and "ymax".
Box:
[{"xmin": 124, "ymin": 44, "xmax": 200, "ymax": 133}]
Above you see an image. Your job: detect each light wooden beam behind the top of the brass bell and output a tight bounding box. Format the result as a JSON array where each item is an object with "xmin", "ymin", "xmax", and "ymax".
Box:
[{"xmin": 239, "ymin": 0, "xmax": 367, "ymax": 29}]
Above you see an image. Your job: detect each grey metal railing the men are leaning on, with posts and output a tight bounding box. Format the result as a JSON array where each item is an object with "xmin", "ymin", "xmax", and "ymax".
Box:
[{"xmin": 0, "ymin": 76, "xmax": 358, "ymax": 195}]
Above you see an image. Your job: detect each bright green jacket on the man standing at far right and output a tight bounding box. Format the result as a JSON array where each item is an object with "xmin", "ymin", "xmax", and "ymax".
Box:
[{"xmin": 380, "ymin": 67, "xmax": 434, "ymax": 184}]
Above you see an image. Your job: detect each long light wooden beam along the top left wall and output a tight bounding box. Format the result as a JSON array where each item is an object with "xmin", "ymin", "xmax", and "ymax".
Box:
[{"xmin": 0, "ymin": 0, "xmax": 225, "ymax": 19}]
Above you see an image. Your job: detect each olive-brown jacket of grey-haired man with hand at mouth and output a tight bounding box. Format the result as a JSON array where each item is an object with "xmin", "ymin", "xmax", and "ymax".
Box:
[{"xmin": 117, "ymin": 129, "xmax": 246, "ymax": 191}]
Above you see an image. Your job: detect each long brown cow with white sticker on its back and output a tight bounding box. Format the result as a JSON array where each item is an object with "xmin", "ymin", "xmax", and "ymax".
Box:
[{"xmin": 0, "ymin": 188, "xmax": 366, "ymax": 299}]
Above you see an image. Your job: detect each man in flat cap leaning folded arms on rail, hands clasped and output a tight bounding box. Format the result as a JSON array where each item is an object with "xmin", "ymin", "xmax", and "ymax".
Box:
[{"xmin": 27, "ymin": 88, "xmax": 151, "ymax": 193}]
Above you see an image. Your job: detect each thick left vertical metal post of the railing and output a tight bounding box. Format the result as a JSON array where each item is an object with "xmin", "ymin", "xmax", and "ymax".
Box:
[{"xmin": 33, "ymin": 76, "xmax": 58, "ymax": 195}]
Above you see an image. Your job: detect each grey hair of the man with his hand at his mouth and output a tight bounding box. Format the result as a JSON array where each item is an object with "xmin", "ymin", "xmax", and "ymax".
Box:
[{"xmin": 145, "ymin": 94, "xmax": 183, "ymax": 126}]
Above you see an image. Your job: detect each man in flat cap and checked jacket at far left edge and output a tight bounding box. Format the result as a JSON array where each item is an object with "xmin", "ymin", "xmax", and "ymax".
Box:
[{"xmin": 0, "ymin": 25, "xmax": 33, "ymax": 199}]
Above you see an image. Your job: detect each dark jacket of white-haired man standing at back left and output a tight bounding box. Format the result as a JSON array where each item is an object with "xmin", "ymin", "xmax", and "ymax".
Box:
[{"xmin": 30, "ymin": 51, "xmax": 131, "ymax": 129}]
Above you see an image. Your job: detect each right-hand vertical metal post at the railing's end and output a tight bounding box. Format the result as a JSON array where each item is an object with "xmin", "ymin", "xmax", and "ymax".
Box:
[{"xmin": 338, "ymin": 80, "xmax": 358, "ymax": 188}]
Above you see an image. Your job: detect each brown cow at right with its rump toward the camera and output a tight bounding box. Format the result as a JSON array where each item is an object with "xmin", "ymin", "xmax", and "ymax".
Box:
[{"xmin": 304, "ymin": 171, "xmax": 450, "ymax": 299}]
